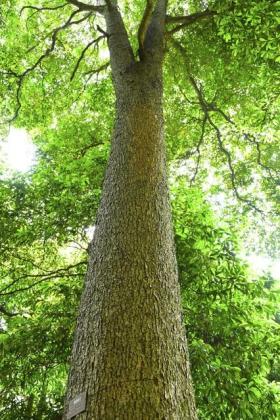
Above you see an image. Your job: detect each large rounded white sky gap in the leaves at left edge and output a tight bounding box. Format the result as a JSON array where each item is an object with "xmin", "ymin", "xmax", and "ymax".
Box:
[{"xmin": 0, "ymin": 127, "xmax": 36, "ymax": 172}]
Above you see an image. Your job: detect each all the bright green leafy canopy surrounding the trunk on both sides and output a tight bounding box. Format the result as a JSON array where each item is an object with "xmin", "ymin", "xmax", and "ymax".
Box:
[{"xmin": 0, "ymin": 0, "xmax": 280, "ymax": 420}]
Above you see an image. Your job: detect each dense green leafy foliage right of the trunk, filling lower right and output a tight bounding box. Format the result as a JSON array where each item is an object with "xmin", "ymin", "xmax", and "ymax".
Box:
[{"xmin": 173, "ymin": 182, "xmax": 280, "ymax": 420}]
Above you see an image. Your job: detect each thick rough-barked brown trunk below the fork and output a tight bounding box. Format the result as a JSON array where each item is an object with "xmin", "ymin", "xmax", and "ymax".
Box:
[{"xmin": 64, "ymin": 63, "xmax": 196, "ymax": 420}]
